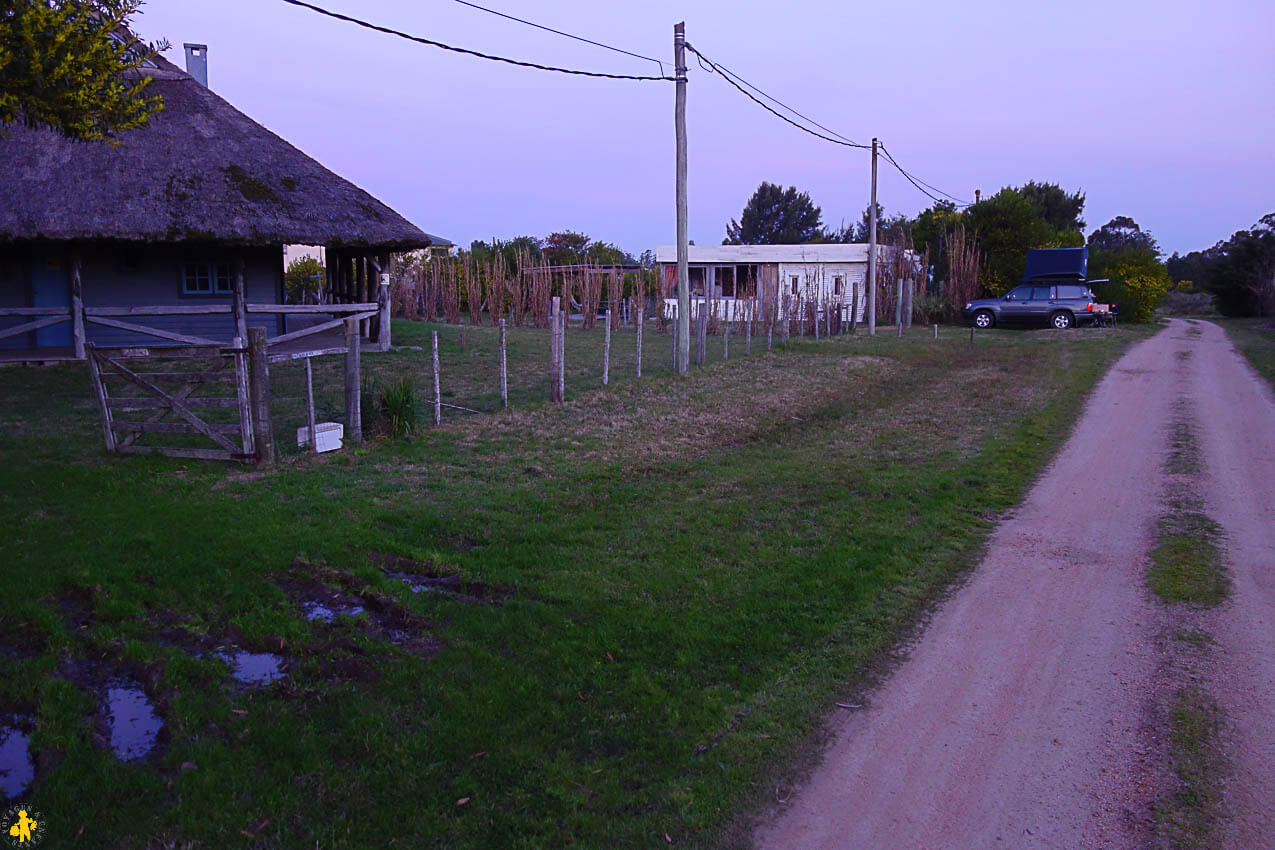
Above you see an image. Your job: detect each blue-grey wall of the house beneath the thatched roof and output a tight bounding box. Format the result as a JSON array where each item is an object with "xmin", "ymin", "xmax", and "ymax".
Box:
[{"xmin": 0, "ymin": 245, "xmax": 283, "ymax": 349}]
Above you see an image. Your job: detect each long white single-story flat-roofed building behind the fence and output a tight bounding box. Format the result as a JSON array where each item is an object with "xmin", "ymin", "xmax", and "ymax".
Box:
[{"xmin": 655, "ymin": 242, "xmax": 890, "ymax": 321}]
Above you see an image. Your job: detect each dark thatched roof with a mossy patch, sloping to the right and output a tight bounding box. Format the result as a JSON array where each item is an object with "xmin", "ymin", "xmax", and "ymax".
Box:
[{"xmin": 0, "ymin": 59, "xmax": 431, "ymax": 250}]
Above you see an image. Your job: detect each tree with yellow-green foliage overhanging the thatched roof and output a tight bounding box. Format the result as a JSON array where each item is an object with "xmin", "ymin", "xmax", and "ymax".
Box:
[{"xmin": 0, "ymin": 0, "xmax": 167, "ymax": 144}]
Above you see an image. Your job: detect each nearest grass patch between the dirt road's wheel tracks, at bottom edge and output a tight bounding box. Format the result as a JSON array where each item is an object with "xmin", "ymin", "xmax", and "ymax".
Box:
[{"xmin": 1155, "ymin": 687, "xmax": 1225, "ymax": 850}]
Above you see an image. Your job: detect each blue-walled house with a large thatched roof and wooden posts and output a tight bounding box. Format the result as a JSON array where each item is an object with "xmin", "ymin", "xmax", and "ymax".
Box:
[{"xmin": 0, "ymin": 44, "xmax": 435, "ymax": 359}]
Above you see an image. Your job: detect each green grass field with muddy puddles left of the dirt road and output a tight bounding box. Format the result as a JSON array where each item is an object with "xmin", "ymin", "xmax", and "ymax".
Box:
[{"xmin": 0, "ymin": 322, "xmax": 1154, "ymax": 847}]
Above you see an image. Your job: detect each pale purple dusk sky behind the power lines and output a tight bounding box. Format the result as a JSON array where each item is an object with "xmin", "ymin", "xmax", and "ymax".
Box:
[{"xmin": 135, "ymin": 0, "xmax": 1275, "ymax": 255}]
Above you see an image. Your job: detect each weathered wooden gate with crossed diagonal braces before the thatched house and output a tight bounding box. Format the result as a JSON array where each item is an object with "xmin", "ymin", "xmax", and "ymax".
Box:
[{"xmin": 85, "ymin": 338, "xmax": 256, "ymax": 461}]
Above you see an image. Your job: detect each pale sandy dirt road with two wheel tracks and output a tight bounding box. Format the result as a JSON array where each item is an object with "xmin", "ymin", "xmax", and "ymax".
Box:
[{"xmin": 755, "ymin": 321, "xmax": 1275, "ymax": 850}]
